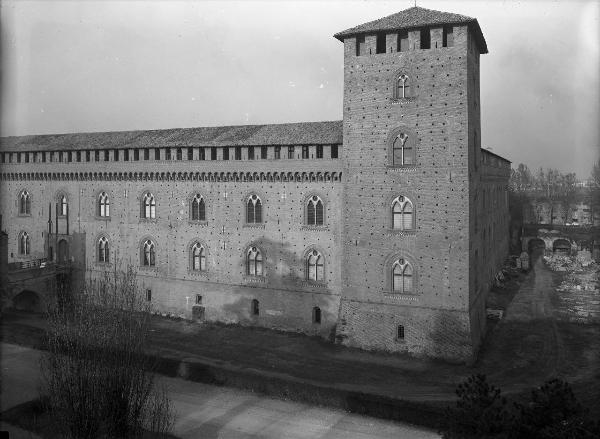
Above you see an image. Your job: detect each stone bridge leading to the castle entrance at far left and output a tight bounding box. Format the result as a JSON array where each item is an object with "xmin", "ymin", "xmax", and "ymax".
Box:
[{"xmin": 1, "ymin": 259, "xmax": 70, "ymax": 312}]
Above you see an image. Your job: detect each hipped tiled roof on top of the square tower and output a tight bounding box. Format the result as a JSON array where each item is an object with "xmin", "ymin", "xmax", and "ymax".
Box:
[{"xmin": 334, "ymin": 6, "xmax": 487, "ymax": 53}]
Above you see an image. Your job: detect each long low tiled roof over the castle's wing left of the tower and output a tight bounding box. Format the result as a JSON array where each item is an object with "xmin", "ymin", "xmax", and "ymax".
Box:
[{"xmin": 0, "ymin": 120, "xmax": 342, "ymax": 151}]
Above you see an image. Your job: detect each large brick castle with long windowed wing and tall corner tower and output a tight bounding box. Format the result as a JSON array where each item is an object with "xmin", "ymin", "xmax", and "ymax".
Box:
[{"xmin": 0, "ymin": 7, "xmax": 510, "ymax": 360}]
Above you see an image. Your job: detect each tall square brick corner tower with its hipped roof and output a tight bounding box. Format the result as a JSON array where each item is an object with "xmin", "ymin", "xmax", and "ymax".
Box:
[{"xmin": 335, "ymin": 7, "xmax": 487, "ymax": 360}]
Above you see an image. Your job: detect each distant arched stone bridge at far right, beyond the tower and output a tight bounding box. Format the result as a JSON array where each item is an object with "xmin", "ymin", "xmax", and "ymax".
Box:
[{"xmin": 521, "ymin": 224, "xmax": 600, "ymax": 253}]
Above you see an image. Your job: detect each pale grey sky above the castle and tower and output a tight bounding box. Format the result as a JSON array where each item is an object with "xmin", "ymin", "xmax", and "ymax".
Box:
[{"xmin": 0, "ymin": 0, "xmax": 600, "ymax": 179}]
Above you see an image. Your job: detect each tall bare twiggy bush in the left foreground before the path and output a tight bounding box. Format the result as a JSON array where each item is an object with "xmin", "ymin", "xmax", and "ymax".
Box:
[{"xmin": 41, "ymin": 269, "xmax": 173, "ymax": 439}]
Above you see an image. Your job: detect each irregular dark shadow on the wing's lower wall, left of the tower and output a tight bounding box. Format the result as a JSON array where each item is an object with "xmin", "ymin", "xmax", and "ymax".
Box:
[{"xmin": 222, "ymin": 238, "xmax": 339, "ymax": 339}]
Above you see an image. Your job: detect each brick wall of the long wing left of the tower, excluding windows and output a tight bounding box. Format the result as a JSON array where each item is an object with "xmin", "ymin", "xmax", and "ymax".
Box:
[{"xmin": 0, "ymin": 156, "xmax": 341, "ymax": 337}]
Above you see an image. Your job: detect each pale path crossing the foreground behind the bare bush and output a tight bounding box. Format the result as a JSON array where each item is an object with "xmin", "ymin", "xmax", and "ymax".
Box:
[{"xmin": 1, "ymin": 343, "xmax": 439, "ymax": 439}]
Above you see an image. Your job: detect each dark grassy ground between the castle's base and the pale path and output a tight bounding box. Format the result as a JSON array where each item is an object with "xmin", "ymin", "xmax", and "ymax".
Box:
[{"xmin": 2, "ymin": 258, "xmax": 600, "ymax": 428}]
